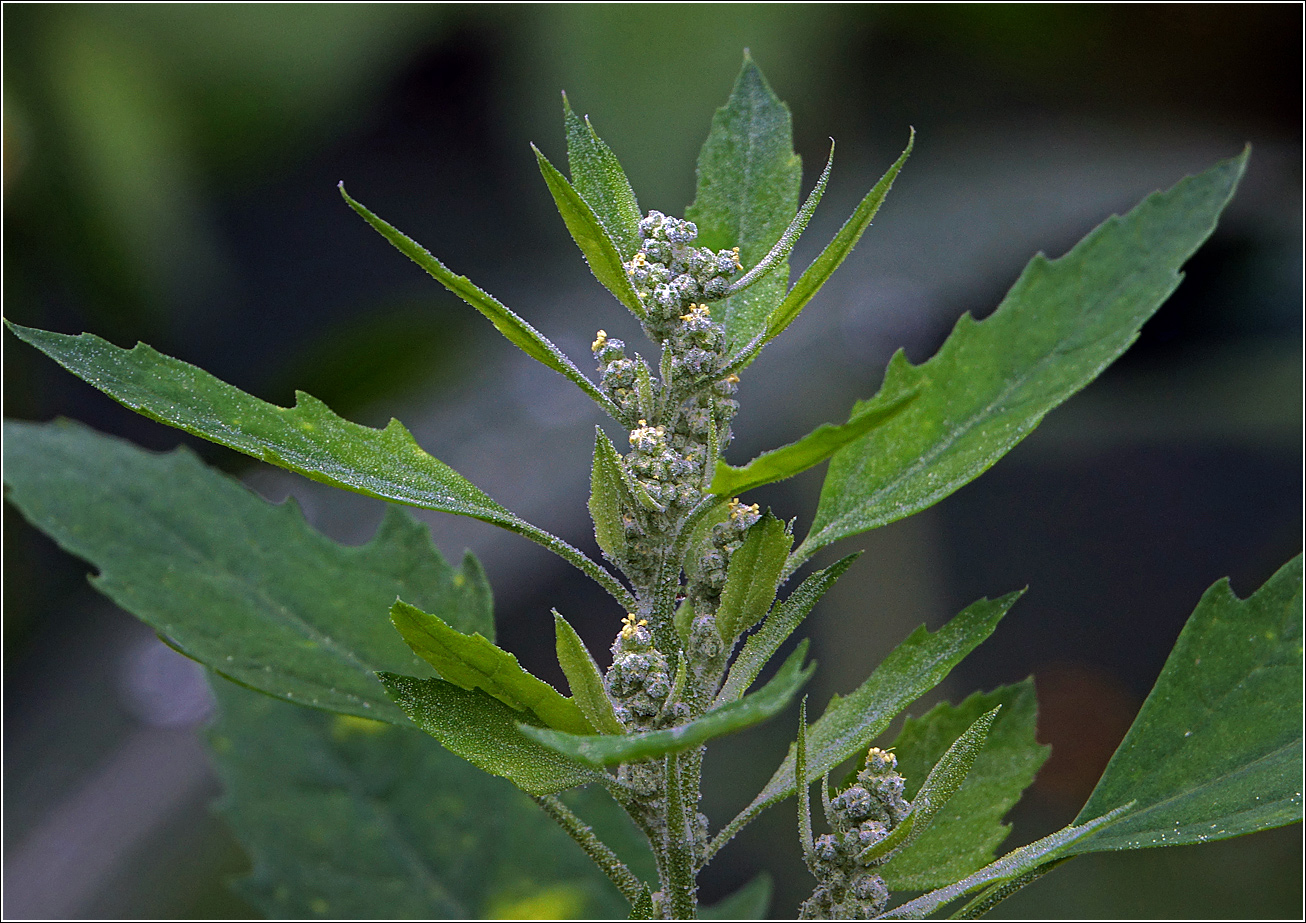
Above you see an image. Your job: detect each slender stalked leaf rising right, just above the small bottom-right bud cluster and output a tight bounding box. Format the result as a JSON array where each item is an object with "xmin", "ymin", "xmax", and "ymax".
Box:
[{"xmin": 708, "ymin": 591, "xmax": 1021, "ymax": 858}]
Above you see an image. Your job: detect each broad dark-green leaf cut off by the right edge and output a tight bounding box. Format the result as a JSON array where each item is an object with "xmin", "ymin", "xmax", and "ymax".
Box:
[{"xmin": 1071, "ymin": 555, "xmax": 1302, "ymax": 853}]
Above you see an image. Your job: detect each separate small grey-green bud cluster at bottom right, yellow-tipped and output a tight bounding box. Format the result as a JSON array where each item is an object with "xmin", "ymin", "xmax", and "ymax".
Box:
[{"xmin": 801, "ymin": 747, "xmax": 912, "ymax": 920}]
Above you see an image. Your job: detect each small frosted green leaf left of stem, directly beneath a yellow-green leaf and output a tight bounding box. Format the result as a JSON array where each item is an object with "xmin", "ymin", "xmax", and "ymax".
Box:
[{"xmin": 377, "ymin": 672, "xmax": 603, "ymax": 795}]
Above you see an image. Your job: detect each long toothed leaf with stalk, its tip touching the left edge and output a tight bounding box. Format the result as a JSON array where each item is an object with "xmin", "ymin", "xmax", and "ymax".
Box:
[{"xmin": 5, "ymin": 321, "xmax": 633, "ymax": 608}]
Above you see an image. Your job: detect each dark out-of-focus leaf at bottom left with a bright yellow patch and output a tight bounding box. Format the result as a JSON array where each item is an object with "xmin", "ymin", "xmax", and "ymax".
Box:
[{"xmin": 208, "ymin": 673, "xmax": 629, "ymax": 919}]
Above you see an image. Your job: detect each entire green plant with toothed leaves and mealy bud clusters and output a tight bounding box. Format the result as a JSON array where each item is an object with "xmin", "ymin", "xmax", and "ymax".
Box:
[{"xmin": 5, "ymin": 57, "xmax": 1302, "ymax": 919}]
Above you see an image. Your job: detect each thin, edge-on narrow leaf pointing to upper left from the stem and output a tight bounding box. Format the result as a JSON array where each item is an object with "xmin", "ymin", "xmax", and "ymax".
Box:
[{"xmin": 340, "ymin": 183, "xmax": 620, "ymax": 416}]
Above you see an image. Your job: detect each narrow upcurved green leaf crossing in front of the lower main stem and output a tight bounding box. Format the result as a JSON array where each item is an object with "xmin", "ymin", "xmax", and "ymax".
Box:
[{"xmin": 521, "ymin": 641, "xmax": 816, "ymax": 766}]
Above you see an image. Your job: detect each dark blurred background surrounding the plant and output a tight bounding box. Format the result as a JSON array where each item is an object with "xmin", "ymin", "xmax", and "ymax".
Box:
[{"xmin": 0, "ymin": 4, "xmax": 1302, "ymax": 918}]
